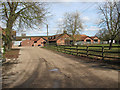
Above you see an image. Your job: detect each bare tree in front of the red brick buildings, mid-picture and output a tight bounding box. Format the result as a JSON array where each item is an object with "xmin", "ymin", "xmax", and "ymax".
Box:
[{"xmin": 59, "ymin": 12, "xmax": 83, "ymax": 44}]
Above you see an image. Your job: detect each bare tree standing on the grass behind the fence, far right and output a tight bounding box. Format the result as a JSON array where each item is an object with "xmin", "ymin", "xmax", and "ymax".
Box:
[{"xmin": 99, "ymin": 1, "xmax": 120, "ymax": 49}]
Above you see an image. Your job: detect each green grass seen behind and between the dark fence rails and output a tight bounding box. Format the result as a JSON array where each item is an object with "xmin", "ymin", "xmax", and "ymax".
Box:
[{"xmin": 44, "ymin": 44, "xmax": 120, "ymax": 60}]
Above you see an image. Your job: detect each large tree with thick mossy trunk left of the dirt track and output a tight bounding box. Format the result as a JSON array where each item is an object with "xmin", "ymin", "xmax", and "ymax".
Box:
[{"xmin": 0, "ymin": 0, "xmax": 48, "ymax": 50}]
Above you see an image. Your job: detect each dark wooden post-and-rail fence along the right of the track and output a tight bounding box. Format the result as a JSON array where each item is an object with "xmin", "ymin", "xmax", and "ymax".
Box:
[{"xmin": 46, "ymin": 45, "xmax": 120, "ymax": 60}]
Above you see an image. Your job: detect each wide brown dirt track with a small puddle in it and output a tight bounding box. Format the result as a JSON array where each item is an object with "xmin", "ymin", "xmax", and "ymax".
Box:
[{"xmin": 3, "ymin": 47, "xmax": 118, "ymax": 88}]
